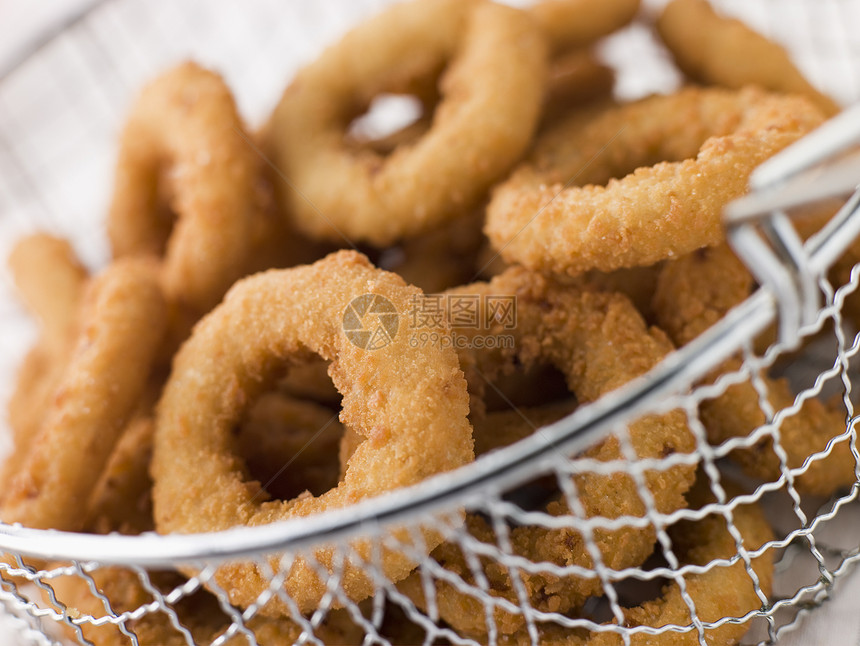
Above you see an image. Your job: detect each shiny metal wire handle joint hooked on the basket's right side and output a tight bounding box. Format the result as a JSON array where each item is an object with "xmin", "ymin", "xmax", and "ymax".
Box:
[{"xmin": 724, "ymin": 104, "xmax": 860, "ymax": 349}]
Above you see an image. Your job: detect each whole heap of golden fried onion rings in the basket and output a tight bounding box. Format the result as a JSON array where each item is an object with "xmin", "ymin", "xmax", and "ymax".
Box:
[{"xmin": 0, "ymin": 0, "xmax": 855, "ymax": 645}]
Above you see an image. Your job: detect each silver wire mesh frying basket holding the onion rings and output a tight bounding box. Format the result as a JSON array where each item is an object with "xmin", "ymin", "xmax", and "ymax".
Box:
[{"xmin": 0, "ymin": 0, "xmax": 860, "ymax": 645}]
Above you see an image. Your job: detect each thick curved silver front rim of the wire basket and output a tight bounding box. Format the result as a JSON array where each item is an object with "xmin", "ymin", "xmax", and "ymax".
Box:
[{"xmin": 0, "ymin": 288, "xmax": 780, "ymax": 567}]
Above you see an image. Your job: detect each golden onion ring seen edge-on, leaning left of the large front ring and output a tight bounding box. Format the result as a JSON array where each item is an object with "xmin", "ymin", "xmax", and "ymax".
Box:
[{"xmin": 0, "ymin": 259, "xmax": 166, "ymax": 531}]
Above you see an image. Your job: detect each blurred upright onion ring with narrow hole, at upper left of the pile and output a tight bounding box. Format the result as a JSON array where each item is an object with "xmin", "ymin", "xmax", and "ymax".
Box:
[{"xmin": 108, "ymin": 63, "xmax": 283, "ymax": 318}]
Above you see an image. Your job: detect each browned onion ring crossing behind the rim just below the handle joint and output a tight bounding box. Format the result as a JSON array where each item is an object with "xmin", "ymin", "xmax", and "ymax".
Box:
[{"xmin": 653, "ymin": 245, "xmax": 856, "ymax": 496}]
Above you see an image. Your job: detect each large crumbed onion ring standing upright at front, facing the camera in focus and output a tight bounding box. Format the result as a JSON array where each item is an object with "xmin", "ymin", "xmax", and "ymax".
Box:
[{"xmin": 152, "ymin": 251, "xmax": 473, "ymax": 613}]
